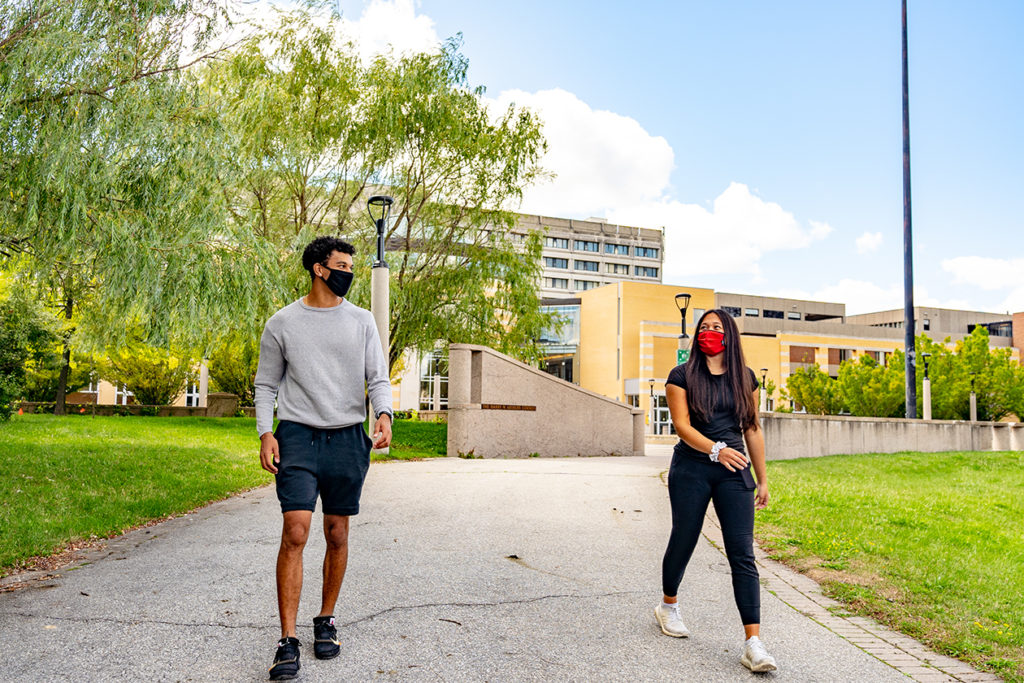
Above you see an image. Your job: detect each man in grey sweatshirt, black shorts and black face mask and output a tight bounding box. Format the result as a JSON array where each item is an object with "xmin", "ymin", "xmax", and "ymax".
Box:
[{"xmin": 255, "ymin": 237, "xmax": 392, "ymax": 681}]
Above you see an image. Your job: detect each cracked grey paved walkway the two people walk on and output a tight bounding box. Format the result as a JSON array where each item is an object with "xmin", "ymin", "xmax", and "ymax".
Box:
[{"xmin": 0, "ymin": 455, "xmax": 995, "ymax": 683}]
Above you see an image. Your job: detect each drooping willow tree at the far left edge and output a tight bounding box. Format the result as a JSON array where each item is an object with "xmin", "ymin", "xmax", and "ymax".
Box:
[{"xmin": 0, "ymin": 0, "xmax": 280, "ymax": 413}]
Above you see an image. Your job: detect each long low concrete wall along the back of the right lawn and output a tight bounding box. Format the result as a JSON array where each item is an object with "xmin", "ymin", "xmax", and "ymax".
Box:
[{"xmin": 761, "ymin": 413, "xmax": 1024, "ymax": 460}]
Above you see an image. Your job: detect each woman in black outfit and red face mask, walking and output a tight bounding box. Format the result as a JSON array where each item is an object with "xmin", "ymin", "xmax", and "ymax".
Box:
[{"xmin": 654, "ymin": 309, "xmax": 777, "ymax": 672}]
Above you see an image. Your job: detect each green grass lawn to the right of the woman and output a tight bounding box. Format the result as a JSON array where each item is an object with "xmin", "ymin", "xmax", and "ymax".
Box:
[{"xmin": 757, "ymin": 452, "xmax": 1024, "ymax": 682}]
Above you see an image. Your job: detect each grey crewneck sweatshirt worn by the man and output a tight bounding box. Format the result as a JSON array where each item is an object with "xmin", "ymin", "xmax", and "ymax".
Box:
[{"xmin": 255, "ymin": 299, "xmax": 392, "ymax": 436}]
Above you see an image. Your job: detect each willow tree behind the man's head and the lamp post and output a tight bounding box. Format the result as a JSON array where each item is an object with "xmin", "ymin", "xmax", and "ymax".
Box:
[{"xmin": 206, "ymin": 14, "xmax": 548, "ymax": 368}]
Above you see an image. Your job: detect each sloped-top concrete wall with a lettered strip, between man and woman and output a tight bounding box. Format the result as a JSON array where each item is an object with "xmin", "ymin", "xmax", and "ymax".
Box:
[{"xmin": 447, "ymin": 344, "xmax": 644, "ymax": 458}]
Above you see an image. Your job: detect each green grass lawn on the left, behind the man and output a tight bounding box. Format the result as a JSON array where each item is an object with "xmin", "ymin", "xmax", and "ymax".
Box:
[{"xmin": 0, "ymin": 415, "xmax": 446, "ymax": 575}]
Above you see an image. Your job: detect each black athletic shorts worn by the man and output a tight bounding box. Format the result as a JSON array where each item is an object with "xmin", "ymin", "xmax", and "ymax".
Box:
[{"xmin": 273, "ymin": 420, "xmax": 373, "ymax": 515}]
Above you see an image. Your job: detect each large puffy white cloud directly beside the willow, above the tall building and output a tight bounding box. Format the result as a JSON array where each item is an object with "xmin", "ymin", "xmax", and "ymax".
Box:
[{"xmin": 490, "ymin": 88, "xmax": 675, "ymax": 217}]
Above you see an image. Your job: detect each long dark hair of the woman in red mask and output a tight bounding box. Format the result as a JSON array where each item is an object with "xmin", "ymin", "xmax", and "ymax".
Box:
[{"xmin": 685, "ymin": 308, "xmax": 758, "ymax": 431}]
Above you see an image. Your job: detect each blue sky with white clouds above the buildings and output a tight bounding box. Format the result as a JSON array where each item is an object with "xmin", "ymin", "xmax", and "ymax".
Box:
[{"xmin": 323, "ymin": 0, "xmax": 1024, "ymax": 312}]
